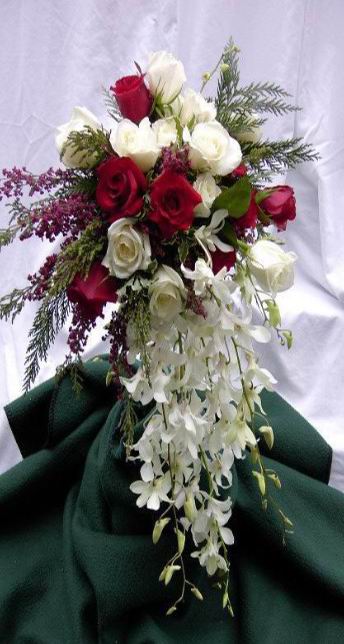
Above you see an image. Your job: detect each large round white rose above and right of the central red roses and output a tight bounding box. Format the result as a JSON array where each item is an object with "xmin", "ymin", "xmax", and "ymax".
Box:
[{"xmin": 184, "ymin": 121, "xmax": 242, "ymax": 176}]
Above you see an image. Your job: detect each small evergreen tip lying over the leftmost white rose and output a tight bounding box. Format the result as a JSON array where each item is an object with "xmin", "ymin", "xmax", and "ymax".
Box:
[{"xmin": 61, "ymin": 125, "xmax": 113, "ymax": 167}]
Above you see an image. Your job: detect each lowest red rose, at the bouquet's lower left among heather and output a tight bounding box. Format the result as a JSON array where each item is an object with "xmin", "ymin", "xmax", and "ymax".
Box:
[{"xmin": 67, "ymin": 262, "xmax": 117, "ymax": 318}]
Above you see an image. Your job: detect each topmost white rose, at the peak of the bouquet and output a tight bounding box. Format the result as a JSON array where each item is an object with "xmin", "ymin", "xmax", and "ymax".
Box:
[{"xmin": 146, "ymin": 51, "xmax": 186, "ymax": 103}]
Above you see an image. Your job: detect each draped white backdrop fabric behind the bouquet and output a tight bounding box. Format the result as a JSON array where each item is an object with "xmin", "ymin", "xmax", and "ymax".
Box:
[{"xmin": 0, "ymin": 0, "xmax": 344, "ymax": 491}]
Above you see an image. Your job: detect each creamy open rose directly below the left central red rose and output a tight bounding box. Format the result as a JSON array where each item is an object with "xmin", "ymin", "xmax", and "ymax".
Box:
[{"xmin": 102, "ymin": 217, "xmax": 151, "ymax": 279}]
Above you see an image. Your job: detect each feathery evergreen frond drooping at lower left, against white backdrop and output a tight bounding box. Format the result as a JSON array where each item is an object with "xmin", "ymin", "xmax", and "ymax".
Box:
[{"xmin": 23, "ymin": 291, "xmax": 70, "ymax": 392}]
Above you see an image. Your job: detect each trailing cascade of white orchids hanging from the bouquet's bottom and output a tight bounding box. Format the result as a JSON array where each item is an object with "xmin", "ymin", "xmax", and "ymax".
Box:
[{"xmin": 122, "ymin": 260, "xmax": 275, "ymax": 575}]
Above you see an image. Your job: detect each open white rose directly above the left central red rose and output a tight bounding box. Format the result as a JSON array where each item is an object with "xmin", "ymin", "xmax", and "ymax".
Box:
[{"xmin": 110, "ymin": 116, "xmax": 160, "ymax": 172}]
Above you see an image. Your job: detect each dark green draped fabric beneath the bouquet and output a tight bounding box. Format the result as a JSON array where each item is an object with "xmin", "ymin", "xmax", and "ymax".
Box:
[{"xmin": 0, "ymin": 358, "xmax": 344, "ymax": 644}]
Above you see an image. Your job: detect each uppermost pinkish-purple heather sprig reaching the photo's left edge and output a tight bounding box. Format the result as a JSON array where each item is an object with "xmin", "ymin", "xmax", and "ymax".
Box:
[{"xmin": 0, "ymin": 167, "xmax": 75, "ymax": 201}]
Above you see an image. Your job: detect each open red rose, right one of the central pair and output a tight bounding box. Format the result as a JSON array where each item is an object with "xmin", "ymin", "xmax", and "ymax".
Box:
[{"xmin": 148, "ymin": 170, "xmax": 202, "ymax": 238}]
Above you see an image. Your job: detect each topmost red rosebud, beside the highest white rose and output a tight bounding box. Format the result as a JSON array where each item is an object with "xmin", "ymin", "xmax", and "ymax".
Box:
[{"xmin": 110, "ymin": 75, "xmax": 153, "ymax": 123}]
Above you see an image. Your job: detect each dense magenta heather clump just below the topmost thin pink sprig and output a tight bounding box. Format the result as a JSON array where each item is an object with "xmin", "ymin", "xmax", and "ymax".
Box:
[{"xmin": 19, "ymin": 193, "xmax": 97, "ymax": 242}]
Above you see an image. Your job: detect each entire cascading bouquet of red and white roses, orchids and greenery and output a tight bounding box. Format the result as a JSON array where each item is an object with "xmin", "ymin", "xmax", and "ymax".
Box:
[{"xmin": 0, "ymin": 41, "xmax": 316, "ymax": 614}]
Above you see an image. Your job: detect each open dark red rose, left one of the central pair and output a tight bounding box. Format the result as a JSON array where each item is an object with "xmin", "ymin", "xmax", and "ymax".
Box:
[{"xmin": 96, "ymin": 157, "xmax": 147, "ymax": 222}]
